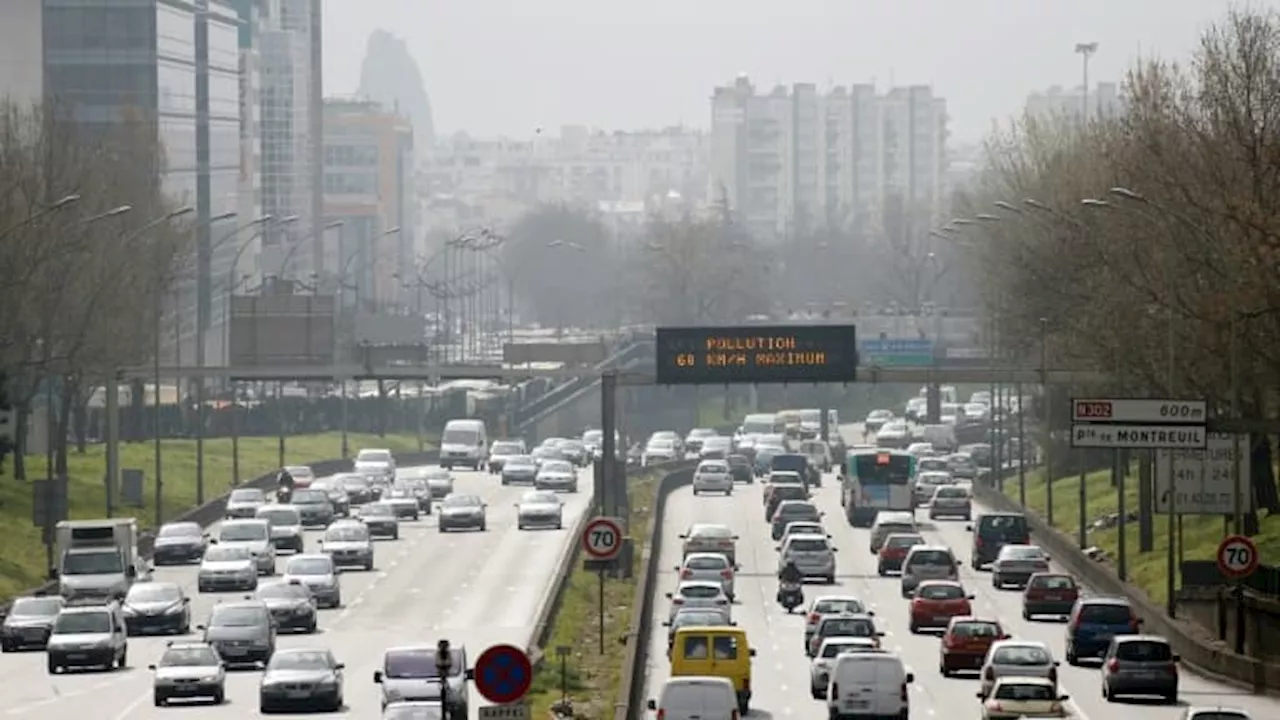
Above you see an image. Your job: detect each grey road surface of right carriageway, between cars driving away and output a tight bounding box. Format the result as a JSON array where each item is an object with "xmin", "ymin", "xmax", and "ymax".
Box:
[{"xmin": 645, "ymin": 427, "xmax": 1280, "ymax": 720}]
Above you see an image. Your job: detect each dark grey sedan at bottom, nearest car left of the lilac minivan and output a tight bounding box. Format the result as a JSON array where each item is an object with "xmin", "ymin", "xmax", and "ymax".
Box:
[{"xmin": 257, "ymin": 647, "xmax": 346, "ymax": 715}]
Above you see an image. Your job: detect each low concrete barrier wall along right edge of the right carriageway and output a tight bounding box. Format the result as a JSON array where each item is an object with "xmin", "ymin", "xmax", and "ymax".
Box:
[{"xmin": 974, "ymin": 466, "xmax": 1280, "ymax": 692}]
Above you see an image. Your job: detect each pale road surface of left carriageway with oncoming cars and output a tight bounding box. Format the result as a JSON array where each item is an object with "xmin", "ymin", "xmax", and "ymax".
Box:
[{"xmin": 0, "ymin": 461, "xmax": 591, "ymax": 720}]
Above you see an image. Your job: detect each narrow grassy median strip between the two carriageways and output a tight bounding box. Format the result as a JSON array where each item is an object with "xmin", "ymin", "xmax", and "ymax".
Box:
[{"xmin": 529, "ymin": 473, "xmax": 662, "ymax": 720}]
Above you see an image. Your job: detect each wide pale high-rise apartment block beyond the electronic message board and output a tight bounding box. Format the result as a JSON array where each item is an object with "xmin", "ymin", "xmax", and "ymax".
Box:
[{"xmin": 709, "ymin": 77, "xmax": 947, "ymax": 238}]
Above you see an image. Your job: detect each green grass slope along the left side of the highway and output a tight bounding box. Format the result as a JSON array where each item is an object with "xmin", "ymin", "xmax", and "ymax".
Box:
[{"xmin": 0, "ymin": 433, "xmax": 434, "ymax": 601}]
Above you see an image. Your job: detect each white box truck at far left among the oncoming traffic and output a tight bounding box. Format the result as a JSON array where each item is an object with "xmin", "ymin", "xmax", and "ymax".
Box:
[{"xmin": 50, "ymin": 518, "xmax": 146, "ymax": 601}]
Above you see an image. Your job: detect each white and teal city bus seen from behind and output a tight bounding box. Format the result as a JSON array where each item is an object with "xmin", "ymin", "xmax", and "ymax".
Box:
[{"xmin": 840, "ymin": 448, "xmax": 915, "ymax": 528}]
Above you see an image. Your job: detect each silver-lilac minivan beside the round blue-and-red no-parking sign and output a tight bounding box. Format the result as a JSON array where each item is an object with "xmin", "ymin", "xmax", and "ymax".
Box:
[{"xmin": 374, "ymin": 646, "xmax": 471, "ymax": 720}]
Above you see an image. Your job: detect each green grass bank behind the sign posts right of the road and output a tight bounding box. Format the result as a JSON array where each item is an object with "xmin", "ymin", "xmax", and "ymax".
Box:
[{"xmin": 1005, "ymin": 465, "xmax": 1280, "ymax": 605}]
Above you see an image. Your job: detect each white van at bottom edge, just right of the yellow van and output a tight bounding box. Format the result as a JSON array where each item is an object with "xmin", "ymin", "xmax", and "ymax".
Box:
[{"xmin": 827, "ymin": 652, "xmax": 915, "ymax": 717}]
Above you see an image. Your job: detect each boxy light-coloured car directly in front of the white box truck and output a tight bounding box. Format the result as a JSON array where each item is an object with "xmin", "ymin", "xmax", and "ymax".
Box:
[{"xmin": 45, "ymin": 602, "xmax": 129, "ymax": 675}]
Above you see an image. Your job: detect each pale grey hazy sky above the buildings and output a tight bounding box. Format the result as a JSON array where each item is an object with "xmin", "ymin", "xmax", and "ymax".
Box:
[{"xmin": 324, "ymin": 0, "xmax": 1280, "ymax": 140}]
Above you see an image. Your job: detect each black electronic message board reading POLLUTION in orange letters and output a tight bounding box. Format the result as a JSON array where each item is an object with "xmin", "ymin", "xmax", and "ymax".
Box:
[{"xmin": 655, "ymin": 325, "xmax": 858, "ymax": 384}]
